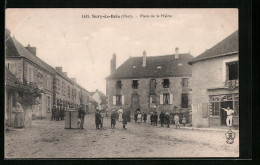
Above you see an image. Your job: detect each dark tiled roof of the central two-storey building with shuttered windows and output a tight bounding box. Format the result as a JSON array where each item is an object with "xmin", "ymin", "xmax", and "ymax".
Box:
[{"xmin": 107, "ymin": 54, "xmax": 193, "ymax": 79}]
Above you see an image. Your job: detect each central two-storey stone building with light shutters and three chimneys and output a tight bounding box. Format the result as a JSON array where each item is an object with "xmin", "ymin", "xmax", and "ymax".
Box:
[{"xmin": 106, "ymin": 48, "xmax": 193, "ymax": 119}]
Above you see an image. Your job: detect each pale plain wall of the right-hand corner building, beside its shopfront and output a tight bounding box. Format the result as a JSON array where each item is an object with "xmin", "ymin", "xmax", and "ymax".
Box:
[{"xmin": 192, "ymin": 55, "xmax": 238, "ymax": 127}]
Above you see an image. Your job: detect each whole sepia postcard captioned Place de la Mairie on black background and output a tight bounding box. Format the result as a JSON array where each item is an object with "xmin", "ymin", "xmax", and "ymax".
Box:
[{"xmin": 3, "ymin": 8, "xmax": 242, "ymax": 159}]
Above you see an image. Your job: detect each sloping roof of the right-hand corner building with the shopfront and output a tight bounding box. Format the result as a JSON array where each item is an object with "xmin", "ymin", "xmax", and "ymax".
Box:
[{"xmin": 189, "ymin": 31, "xmax": 238, "ymax": 64}]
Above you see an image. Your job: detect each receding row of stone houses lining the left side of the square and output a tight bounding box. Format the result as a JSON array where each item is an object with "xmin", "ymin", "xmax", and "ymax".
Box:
[{"xmin": 5, "ymin": 29, "xmax": 89, "ymax": 119}]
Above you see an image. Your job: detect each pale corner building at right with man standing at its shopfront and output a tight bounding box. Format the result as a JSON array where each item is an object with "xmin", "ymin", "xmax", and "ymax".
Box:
[{"xmin": 189, "ymin": 31, "xmax": 239, "ymax": 127}]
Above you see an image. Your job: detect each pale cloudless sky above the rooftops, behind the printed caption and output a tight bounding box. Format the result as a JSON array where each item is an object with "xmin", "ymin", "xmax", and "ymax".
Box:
[{"xmin": 6, "ymin": 9, "xmax": 238, "ymax": 93}]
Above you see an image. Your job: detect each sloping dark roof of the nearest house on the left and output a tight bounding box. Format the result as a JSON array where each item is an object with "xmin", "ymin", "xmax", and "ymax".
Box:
[{"xmin": 6, "ymin": 37, "xmax": 55, "ymax": 74}]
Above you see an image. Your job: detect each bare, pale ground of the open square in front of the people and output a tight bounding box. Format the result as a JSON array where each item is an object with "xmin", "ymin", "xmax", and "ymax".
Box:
[{"xmin": 5, "ymin": 114, "xmax": 239, "ymax": 158}]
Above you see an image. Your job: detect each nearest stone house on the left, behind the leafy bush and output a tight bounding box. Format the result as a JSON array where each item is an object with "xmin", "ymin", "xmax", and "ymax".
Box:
[{"xmin": 5, "ymin": 30, "xmax": 54, "ymax": 118}]
